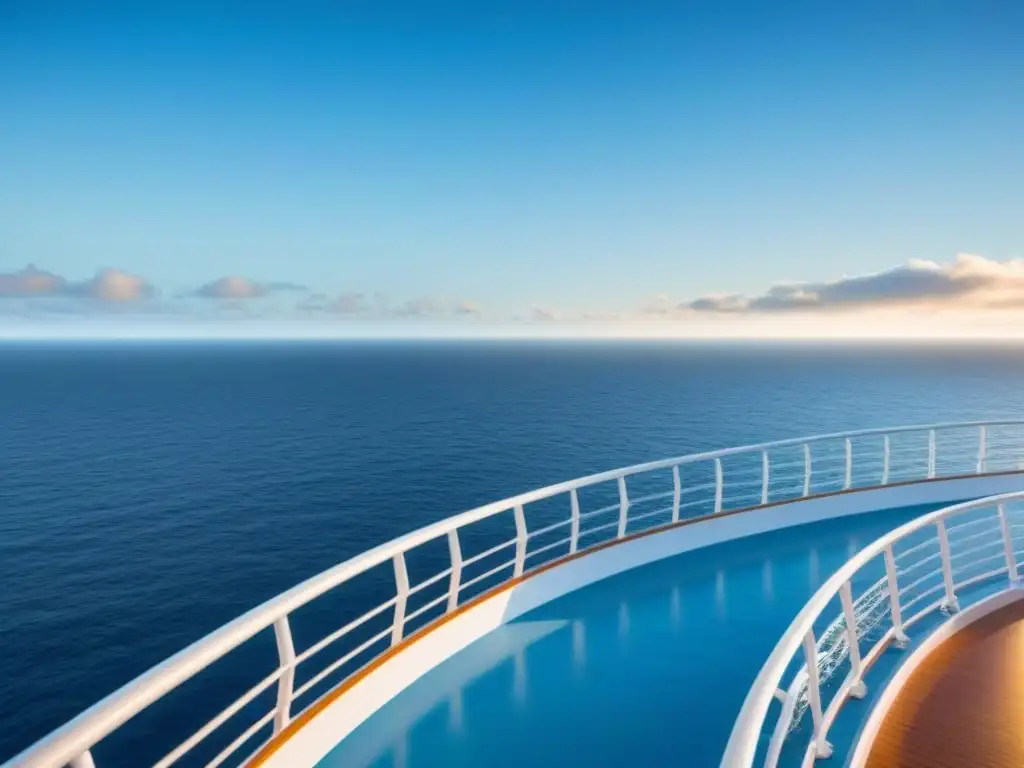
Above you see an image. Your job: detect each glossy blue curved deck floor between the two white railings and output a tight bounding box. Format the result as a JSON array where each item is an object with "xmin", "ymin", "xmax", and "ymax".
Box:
[{"xmin": 311, "ymin": 505, "xmax": 942, "ymax": 768}]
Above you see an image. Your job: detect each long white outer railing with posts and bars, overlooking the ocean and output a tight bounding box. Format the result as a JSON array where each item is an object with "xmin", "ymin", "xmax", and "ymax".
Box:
[{"xmin": 11, "ymin": 421, "xmax": 1024, "ymax": 768}]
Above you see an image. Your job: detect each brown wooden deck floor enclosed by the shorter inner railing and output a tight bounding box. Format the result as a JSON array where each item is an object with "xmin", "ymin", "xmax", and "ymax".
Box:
[{"xmin": 867, "ymin": 601, "xmax": 1024, "ymax": 768}]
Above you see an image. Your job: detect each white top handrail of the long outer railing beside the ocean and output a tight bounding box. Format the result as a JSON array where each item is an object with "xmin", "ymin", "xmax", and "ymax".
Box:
[{"xmin": 7, "ymin": 420, "xmax": 1024, "ymax": 768}]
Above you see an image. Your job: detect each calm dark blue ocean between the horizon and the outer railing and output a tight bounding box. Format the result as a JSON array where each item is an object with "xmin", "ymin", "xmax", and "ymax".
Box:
[{"xmin": 0, "ymin": 342, "xmax": 1024, "ymax": 768}]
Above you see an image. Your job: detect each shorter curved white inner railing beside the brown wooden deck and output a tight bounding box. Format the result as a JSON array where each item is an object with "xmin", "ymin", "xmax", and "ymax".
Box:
[{"xmin": 722, "ymin": 493, "xmax": 1024, "ymax": 768}]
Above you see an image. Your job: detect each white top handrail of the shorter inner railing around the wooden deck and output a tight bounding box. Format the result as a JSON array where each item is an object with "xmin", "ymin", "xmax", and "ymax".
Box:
[{"xmin": 722, "ymin": 492, "xmax": 1024, "ymax": 768}]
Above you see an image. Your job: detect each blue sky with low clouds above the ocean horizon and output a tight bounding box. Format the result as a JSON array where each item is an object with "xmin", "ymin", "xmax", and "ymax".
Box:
[{"xmin": 0, "ymin": 0, "xmax": 1024, "ymax": 336}]
